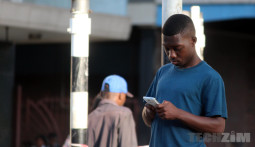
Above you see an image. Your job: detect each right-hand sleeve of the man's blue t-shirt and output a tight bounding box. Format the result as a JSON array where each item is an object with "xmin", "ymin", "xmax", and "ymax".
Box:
[{"xmin": 202, "ymin": 77, "xmax": 228, "ymax": 118}]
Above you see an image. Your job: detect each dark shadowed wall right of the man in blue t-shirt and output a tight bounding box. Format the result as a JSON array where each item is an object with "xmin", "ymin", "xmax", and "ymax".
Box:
[{"xmin": 204, "ymin": 20, "xmax": 255, "ymax": 147}]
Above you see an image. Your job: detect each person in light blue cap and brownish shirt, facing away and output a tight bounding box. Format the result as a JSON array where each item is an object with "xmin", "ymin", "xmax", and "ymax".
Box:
[{"xmin": 87, "ymin": 75, "xmax": 137, "ymax": 147}]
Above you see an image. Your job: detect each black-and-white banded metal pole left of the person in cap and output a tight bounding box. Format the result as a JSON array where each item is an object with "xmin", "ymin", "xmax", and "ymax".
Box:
[{"xmin": 69, "ymin": 0, "xmax": 91, "ymax": 147}]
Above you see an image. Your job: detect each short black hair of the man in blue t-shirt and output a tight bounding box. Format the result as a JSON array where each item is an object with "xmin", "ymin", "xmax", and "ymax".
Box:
[{"xmin": 162, "ymin": 14, "xmax": 195, "ymax": 36}]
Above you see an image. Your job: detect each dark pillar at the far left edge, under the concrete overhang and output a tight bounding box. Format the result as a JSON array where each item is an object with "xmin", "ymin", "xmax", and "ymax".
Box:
[{"xmin": 0, "ymin": 42, "xmax": 15, "ymax": 147}]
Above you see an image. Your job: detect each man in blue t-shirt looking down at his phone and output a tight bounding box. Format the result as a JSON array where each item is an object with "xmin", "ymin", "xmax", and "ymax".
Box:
[{"xmin": 142, "ymin": 14, "xmax": 227, "ymax": 147}]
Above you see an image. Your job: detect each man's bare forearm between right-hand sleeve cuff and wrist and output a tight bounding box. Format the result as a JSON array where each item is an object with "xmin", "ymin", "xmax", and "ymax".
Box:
[{"xmin": 177, "ymin": 109, "xmax": 225, "ymax": 133}]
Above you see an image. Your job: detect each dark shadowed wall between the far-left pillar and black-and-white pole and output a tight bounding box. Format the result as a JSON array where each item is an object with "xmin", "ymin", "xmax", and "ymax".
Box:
[{"xmin": 14, "ymin": 43, "xmax": 71, "ymax": 147}]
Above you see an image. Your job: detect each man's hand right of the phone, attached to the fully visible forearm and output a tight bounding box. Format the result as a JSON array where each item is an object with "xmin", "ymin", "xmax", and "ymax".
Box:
[{"xmin": 156, "ymin": 101, "xmax": 179, "ymax": 120}]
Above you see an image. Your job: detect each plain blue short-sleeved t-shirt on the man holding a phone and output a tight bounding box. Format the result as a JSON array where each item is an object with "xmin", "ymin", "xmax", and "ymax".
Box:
[{"xmin": 146, "ymin": 61, "xmax": 227, "ymax": 147}]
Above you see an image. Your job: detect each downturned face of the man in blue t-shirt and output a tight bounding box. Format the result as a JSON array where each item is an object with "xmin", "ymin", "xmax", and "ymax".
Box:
[{"xmin": 163, "ymin": 33, "xmax": 196, "ymax": 68}]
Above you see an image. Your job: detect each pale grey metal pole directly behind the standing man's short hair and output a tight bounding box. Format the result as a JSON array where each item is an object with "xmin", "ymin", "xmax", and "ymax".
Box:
[{"xmin": 161, "ymin": 0, "xmax": 182, "ymax": 65}]
